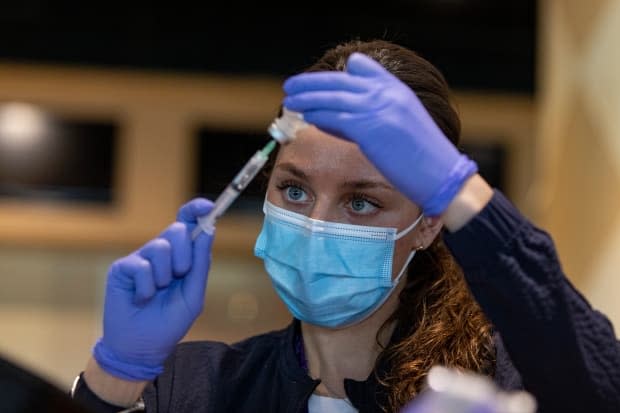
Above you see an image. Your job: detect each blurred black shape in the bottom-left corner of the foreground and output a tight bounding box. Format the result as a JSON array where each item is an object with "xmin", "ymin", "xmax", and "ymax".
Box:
[{"xmin": 0, "ymin": 357, "xmax": 91, "ymax": 413}]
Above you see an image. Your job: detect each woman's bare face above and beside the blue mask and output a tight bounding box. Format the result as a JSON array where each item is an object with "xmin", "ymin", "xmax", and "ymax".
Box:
[{"xmin": 267, "ymin": 126, "xmax": 422, "ymax": 277}]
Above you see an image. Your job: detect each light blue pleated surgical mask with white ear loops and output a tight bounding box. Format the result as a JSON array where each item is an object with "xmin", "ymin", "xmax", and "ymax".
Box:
[{"xmin": 254, "ymin": 201, "xmax": 422, "ymax": 328}]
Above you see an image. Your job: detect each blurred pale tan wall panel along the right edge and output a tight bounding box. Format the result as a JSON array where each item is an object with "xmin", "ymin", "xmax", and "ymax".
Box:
[{"xmin": 532, "ymin": 0, "xmax": 620, "ymax": 331}]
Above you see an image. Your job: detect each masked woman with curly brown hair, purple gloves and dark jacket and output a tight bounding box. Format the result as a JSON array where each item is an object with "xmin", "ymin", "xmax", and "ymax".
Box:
[{"xmin": 70, "ymin": 41, "xmax": 620, "ymax": 412}]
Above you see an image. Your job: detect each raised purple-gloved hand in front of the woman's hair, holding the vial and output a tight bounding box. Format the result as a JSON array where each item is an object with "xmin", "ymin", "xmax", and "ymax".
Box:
[{"xmin": 284, "ymin": 53, "xmax": 477, "ymax": 216}]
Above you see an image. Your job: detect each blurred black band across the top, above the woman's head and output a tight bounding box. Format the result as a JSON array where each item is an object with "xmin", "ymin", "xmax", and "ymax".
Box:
[{"xmin": 0, "ymin": 0, "xmax": 536, "ymax": 93}]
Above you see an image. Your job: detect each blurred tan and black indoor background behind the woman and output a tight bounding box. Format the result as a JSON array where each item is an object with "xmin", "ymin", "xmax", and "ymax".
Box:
[{"xmin": 0, "ymin": 0, "xmax": 620, "ymax": 388}]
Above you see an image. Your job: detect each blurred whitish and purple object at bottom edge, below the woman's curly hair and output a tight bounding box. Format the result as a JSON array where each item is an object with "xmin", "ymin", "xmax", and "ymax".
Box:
[{"xmin": 401, "ymin": 366, "xmax": 536, "ymax": 413}]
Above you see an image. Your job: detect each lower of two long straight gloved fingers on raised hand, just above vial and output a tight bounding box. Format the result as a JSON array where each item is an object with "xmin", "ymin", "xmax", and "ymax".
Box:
[{"xmin": 283, "ymin": 90, "xmax": 377, "ymax": 112}]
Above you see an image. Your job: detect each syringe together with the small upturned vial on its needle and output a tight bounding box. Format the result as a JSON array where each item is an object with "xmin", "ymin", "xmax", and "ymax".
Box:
[{"xmin": 192, "ymin": 108, "xmax": 308, "ymax": 239}]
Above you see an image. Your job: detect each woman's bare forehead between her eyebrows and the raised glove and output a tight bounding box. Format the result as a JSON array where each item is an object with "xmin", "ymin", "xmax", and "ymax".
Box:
[{"xmin": 275, "ymin": 126, "xmax": 387, "ymax": 184}]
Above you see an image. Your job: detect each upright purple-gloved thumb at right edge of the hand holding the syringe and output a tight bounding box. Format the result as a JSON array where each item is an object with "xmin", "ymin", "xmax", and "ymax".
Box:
[{"xmin": 182, "ymin": 232, "xmax": 213, "ymax": 316}]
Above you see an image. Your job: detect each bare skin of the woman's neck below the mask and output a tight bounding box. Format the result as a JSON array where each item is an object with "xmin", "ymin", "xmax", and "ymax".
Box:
[{"xmin": 301, "ymin": 274, "xmax": 406, "ymax": 398}]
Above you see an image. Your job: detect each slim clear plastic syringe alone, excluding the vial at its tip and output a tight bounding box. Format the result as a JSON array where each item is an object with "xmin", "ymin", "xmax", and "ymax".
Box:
[{"xmin": 192, "ymin": 140, "xmax": 276, "ymax": 239}]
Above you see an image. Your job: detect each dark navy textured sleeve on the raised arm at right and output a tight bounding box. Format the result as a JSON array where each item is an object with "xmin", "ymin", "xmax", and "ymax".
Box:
[{"xmin": 445, "ymin": 190, "xmax": 620, "ymax": 413}]
